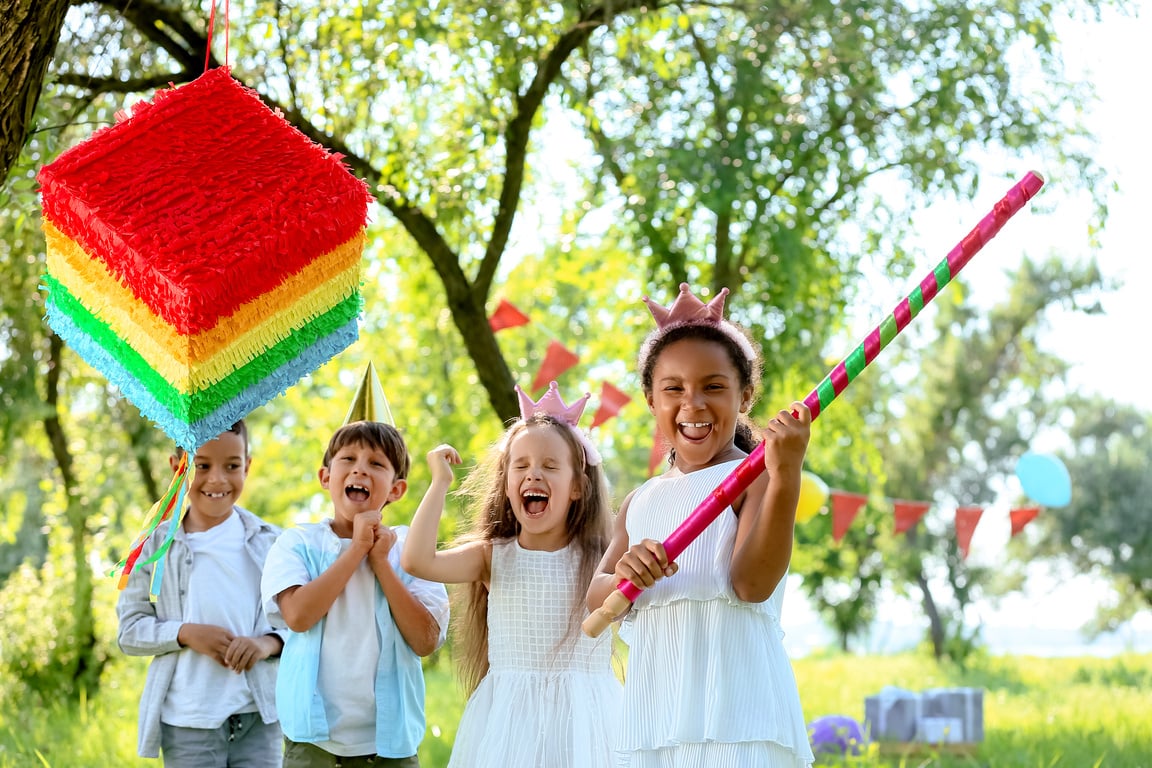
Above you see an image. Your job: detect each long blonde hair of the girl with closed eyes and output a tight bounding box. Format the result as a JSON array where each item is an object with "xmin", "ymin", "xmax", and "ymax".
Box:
[{"xmin": 453, "ymin": 413, "xmax": 612, "ymax": 694}]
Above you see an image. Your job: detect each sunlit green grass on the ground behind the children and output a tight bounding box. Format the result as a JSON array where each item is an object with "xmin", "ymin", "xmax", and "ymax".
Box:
[{"xmin": 0, "ymin": 654, "xmax": 1152, "ymax": 768}]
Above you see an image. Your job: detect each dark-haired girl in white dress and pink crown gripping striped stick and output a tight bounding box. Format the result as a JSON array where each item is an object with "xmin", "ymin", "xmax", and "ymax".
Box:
[{"xmin": 588, "ymin": 284, "xmax": 813, "ymax": 768}]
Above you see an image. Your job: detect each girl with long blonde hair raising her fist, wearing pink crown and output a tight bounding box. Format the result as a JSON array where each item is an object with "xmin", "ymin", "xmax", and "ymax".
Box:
[{"xmin": 401, "ymin": 382, "xmax": 622, "ymax": 768}]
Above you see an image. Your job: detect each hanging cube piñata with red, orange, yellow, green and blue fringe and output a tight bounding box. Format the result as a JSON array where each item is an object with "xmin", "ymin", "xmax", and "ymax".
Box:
[{"xmin": 39, "ymin": 68, "xmax": 369, "ymax": 449}]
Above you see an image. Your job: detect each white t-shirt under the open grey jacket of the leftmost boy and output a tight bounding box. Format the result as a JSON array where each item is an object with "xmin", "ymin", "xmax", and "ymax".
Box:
[{"xmin": 160, "ymin": 512, "xmax": 260, "ymax": 728}]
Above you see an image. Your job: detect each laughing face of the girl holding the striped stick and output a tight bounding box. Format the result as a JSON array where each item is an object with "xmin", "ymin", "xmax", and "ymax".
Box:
[{"xmin": 647, "ymin": 339, "xmax": 753, "ymax": 472}]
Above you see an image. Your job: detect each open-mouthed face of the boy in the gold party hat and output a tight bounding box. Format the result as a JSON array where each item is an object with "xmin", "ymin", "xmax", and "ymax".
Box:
[{"xmin": 320, "ymin": 442, "xmax": 408, "ymax": 539}]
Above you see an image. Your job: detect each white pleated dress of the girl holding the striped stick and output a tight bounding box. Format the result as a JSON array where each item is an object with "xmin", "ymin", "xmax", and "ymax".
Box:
[{"xmin": 620, "ymin": 462, "xmax": 814, "ymax": 768}]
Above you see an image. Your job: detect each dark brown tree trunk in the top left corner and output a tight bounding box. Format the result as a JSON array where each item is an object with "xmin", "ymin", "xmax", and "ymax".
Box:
[{"xmin": 0, "ymin": 0, "xmax": 71, "ymax": 181}]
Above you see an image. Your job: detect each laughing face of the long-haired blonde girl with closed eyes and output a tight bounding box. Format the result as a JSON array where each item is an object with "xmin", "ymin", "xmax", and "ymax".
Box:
[{"xmin": 505, "ymin": 424, "xmax": 579, "ymax": 552}]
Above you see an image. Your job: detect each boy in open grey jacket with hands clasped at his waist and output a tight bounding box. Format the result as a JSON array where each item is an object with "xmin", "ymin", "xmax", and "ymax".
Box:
[{"xmin": 116, "ymin": 420, "xmax": 283, "ymax": 768}]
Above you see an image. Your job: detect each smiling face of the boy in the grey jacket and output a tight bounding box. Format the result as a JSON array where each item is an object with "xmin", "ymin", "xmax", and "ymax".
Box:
[{"xmin": 180, "ymin": 432, "xmax": 252, "ymax": 533}]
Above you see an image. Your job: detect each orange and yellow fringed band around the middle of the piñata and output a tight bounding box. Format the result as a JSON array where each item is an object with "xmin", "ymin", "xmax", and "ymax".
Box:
[{"xmin": 44, "ymin": 220, "xmax": 364, "ymax": 393}]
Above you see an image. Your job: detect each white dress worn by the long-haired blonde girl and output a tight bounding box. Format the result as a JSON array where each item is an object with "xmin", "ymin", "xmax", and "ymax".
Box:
[{"xmin": 448, "ymin": 539, "xmax": 622, "ymax": 768}]
